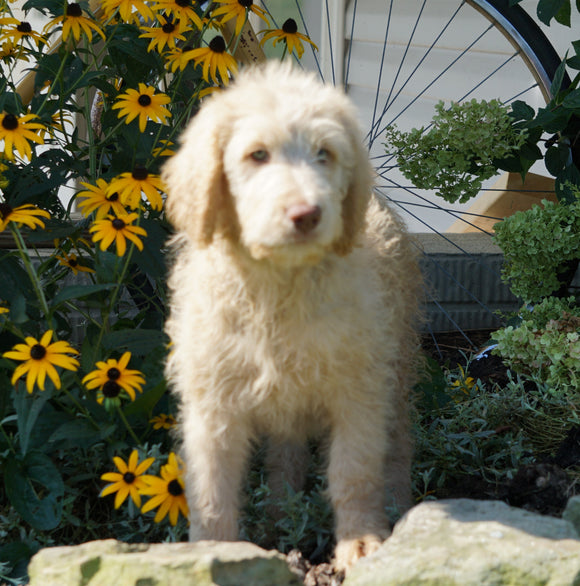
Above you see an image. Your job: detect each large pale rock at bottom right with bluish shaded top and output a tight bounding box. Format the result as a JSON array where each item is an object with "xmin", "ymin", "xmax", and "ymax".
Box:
[{"xmin": 343, "ymin": 499, "xmax": 580, "ymax": 586}]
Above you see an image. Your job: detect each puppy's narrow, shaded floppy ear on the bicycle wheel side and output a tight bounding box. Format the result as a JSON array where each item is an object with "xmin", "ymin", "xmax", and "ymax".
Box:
[{"xmin": 334, "ymin": 116, "xmax": 375, "ymax": 256}]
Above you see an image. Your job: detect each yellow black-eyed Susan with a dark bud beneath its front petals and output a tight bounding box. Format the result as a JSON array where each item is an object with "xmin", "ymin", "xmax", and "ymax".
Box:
[{"xmin": 83, "ymin": 352, "xmax": 145, "ymax": 403}]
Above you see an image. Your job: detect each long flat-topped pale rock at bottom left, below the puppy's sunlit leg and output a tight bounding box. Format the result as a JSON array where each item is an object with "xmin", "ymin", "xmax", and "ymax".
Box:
[{"xmin": 28, "ymin": 539, "xmax": 302, "ymax": 586}]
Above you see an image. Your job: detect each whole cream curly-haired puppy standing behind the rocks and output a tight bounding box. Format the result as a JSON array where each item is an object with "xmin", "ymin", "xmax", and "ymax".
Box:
[{"xmin": 163, "ymin": 64, "xmax": 420, "ymax": 568}]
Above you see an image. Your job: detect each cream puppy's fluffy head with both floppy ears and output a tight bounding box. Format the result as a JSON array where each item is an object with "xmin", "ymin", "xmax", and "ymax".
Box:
[{"xmin": 163, "ymin": 63, "xmax": 373, "ymax": 265}]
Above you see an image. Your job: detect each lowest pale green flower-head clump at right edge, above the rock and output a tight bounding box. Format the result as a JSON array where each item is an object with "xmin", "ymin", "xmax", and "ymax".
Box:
[{"xmin": 493, "ymin": 297, "xmax": 580, "ymax": 390}]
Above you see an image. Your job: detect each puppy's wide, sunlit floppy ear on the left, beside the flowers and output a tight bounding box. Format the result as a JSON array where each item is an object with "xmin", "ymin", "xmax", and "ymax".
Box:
[{"xmin": 162, "ymin": 98, "xmax": 239, "ymax": 246}]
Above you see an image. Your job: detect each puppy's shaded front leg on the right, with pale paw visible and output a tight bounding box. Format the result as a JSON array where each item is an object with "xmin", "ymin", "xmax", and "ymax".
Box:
[{"xmin": 328, "ymin": 404, "xmax": 390, "ymax": 570}]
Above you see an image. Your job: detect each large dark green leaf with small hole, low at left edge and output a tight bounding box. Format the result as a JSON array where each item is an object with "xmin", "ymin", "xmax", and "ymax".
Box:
[{"xmin": 4, "ymin": 452, "xmax": 64, "ymax": 531}]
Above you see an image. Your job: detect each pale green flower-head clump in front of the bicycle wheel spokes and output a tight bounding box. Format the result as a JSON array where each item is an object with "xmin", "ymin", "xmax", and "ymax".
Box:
[{"xmin": 386, "ymin": 100, "xmax": 527, "ymax": 202}]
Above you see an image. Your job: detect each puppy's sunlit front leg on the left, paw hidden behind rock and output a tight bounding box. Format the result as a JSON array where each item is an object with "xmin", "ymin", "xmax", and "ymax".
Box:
[{"xmin": 183, "ymin": 416, "xmax": 250, "ymax": 541}]
